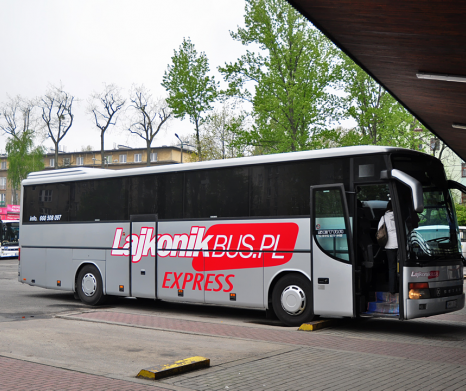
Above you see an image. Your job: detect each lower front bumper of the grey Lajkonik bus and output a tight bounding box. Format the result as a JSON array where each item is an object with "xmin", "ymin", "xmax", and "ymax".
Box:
[{"xmin": 406, "ymin": 293, "xmax": 465, "ymax": 319}]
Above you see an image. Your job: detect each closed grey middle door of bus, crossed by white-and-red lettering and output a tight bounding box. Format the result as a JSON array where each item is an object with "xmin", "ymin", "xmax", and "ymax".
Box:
[{"xmin": 129, "ymin": 214, "xmax": 157, "ymax": 299}]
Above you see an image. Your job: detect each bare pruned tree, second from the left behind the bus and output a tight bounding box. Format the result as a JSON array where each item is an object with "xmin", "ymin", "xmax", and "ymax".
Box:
[{"xmin": 39, "ymin": 85, "xmax": 75, "ymax": 169}]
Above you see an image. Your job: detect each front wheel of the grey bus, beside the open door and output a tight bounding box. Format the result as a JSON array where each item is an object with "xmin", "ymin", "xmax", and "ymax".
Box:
[{"xmin": 272, "ymin": 273, "xmax": 313, "ymax": 326}]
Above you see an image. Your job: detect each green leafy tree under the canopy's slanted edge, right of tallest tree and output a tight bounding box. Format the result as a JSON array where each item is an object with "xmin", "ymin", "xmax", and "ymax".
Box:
[{"xmin": 344, "ymin": 57, "xmax": 428, "ymax": 150}]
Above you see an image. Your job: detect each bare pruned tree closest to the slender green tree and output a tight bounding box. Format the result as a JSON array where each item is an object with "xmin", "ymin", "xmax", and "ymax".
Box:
[{"xmin": 128, "ymin": 85, "xmax": 172, "ymax": 166}]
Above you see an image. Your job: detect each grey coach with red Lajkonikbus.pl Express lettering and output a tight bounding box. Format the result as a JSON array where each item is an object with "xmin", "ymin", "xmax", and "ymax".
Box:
[{"xmin": 18, "ymin": 146, "xmax": 466, "ymax": 326}]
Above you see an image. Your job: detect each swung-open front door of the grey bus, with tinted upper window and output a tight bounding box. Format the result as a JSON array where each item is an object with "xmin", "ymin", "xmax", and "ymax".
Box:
[{"xmin": 311, "ymin": 184, "xmax": 356, "ymax": 317}]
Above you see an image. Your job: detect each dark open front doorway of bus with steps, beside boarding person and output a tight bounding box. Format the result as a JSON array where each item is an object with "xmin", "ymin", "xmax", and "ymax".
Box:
[{"xmin": 356, "ymin": 183, "xmax": 400, "ymax": 317}]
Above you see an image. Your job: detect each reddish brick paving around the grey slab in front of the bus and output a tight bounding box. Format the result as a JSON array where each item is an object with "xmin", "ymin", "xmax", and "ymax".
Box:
[{"xmin": 0, "ymin": 308, "xmax": 466, "ymax": 391}]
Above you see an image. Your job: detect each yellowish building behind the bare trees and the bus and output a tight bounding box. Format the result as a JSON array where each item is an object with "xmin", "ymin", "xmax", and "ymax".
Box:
[{"xmin": 0, "ymin": 145, "xmax": 193, "ymax": 207}]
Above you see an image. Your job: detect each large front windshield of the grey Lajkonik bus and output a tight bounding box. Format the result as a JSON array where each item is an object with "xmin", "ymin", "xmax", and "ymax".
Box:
[{"xmin": 394, "ymin": 157, "xmax": 461, "ymax": 260}]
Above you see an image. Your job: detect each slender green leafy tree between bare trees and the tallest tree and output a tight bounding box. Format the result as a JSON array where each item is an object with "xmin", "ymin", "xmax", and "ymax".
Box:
[{"xmin": 162, "ymin": 38, "xmax": 218, "ymax": 160}]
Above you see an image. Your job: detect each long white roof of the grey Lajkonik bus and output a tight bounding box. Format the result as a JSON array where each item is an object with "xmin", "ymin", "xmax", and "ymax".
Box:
[{"xmin": 22, "ymin": 146, "xmax": 430, "ymax": 186}]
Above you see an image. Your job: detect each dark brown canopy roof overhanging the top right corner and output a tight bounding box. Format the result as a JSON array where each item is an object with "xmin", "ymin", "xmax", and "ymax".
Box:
[{"xmin": 288, "ymin": 0, "xmax": 466, "ymax": 160}]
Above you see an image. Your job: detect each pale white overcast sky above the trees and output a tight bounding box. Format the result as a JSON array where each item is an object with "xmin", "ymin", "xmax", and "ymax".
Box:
[{"xmin": 0, "ymin": 0, "xmax": 249, "ymax": 152}]
